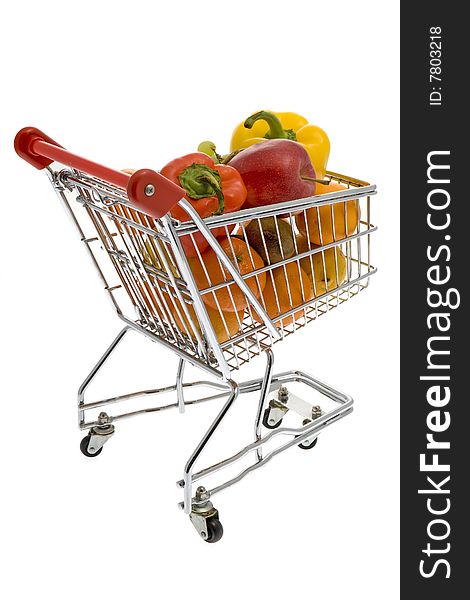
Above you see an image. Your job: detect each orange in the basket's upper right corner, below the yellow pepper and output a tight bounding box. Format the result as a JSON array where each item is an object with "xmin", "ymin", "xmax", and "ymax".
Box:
[{"xmin": 295, "ymin": 183, "xmax": 359, "ymax": 246}]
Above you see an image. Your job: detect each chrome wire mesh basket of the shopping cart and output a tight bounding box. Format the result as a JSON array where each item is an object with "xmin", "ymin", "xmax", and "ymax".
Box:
[{"xmin": 55, "ymin": 170, "xmax": 376, "ymax": 372}]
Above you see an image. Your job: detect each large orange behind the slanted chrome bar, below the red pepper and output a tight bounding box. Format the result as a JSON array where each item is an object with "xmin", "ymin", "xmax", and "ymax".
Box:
[{"xmin": 189, "ymin": 237, "xmax": 266, "ymax": 312}]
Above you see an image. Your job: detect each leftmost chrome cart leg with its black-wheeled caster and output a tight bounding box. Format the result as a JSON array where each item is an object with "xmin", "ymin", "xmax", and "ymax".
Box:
[{"xmin": 78, "ymin": 326, "xmax": 130, "ymax": 457}]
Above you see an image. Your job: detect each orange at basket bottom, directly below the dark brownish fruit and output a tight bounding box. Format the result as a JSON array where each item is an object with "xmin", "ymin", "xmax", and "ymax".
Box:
[{"xmin": 253, "ymin": 262, "xmax": 314, "ymax": 326}]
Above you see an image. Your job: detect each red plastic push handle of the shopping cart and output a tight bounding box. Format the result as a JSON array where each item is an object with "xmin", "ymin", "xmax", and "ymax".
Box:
[{"xmin": 15, "ymin": 127, "xmax": 185, "ymax": 219}]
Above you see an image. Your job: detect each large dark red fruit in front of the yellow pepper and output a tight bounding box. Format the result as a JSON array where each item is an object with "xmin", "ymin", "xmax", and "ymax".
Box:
[{"xmin": 230, "ymin": 139, "xmax": 315, "ymax": 208}]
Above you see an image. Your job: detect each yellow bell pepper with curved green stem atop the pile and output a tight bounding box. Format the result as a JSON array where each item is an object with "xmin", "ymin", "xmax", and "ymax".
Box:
[{"xmin": 230, "ymin": 110, "xmax": 330, "ymax": 179}]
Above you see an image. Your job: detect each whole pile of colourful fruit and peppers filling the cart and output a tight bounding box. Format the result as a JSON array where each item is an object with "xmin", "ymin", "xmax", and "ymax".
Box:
[{"xmin": 138, "ymin": 111, "xmax": 359, "ymax": 343}]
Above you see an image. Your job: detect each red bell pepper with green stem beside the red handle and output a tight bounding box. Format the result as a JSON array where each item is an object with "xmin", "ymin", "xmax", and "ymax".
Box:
[{"xmin": 161, "ymin": 152, "xmax": 247, "ymax": 256}]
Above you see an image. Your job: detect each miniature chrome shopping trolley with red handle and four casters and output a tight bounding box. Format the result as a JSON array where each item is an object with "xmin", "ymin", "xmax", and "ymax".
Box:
[{"xmin": 15, "ymin": 127, "xmax": 376, "ymax": 543}]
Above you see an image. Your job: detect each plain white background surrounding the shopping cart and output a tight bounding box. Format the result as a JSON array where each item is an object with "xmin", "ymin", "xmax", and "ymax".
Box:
[{"xmin": 0, "ymin": 0, "xmax": 399, "ymax": 600}]
